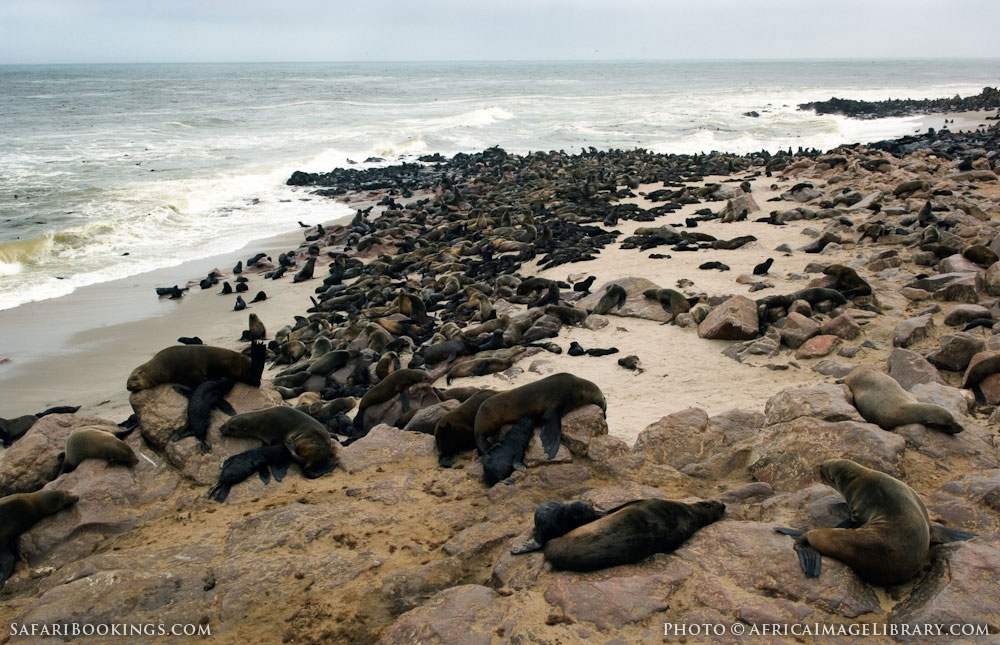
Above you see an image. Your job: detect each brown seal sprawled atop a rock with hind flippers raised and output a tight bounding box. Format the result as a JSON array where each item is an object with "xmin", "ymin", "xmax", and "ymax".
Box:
[{"xmin": 125, "ymin": 343, "xmax": 267, "ymax": 392}]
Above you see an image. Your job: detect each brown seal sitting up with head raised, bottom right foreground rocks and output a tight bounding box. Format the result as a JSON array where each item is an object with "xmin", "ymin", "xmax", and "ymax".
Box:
[{"xmin": 777, "ymin": 459, "xmax": 973, "ymax": 585}]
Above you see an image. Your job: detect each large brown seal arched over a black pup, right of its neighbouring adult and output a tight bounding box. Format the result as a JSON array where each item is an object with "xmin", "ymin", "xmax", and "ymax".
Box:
[{"xmin": 474, "ymin": 372, "xmax": 608, "ymax": 459}]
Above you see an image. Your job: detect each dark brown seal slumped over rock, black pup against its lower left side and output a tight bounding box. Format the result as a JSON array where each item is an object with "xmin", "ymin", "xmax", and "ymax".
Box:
[{"xmin": 219, "ymin": 405, "xmax": 337, "ymax": 479}]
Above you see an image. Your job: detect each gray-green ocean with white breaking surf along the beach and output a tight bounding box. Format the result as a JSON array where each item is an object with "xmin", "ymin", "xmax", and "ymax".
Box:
[{"xmin": 0, "ymin": 60, "xmax": 1000, "ymax": 309}]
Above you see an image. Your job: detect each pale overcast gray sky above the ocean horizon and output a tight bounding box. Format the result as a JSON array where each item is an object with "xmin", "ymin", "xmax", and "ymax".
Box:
[{"xmin": 0, "ymin": 0, "xmax": 1000, "ymax": 63}]
